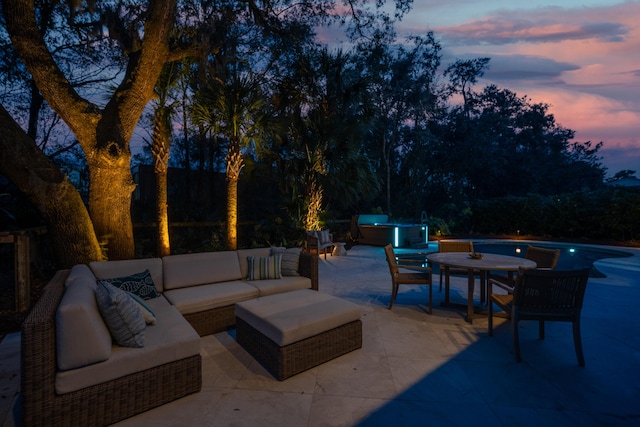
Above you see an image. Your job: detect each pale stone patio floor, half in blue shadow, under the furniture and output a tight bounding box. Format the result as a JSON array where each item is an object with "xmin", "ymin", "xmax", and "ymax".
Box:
[{"xmin": 0, "ymin": 242, "xmax": 640, "ymax": 427}]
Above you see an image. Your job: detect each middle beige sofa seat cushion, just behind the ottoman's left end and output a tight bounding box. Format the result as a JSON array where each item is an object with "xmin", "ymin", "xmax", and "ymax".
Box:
[{"xmin": 164, "ymin": 280, "xmax": 259, "ymax": 314}]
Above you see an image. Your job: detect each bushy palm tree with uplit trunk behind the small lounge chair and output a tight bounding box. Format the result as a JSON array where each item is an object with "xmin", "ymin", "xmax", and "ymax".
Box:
[{"xmin": 275, "ymin": 49, "xmax": 380, "ymax": 234}]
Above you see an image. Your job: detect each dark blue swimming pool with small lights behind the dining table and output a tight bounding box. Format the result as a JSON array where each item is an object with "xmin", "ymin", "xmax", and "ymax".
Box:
[{"xmin": 403, "ymin": 240, "xmax": 633, "ymax": 277}]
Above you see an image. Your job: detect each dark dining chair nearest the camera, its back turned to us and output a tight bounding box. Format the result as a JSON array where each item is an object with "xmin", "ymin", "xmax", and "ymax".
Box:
[{"xmin": 488, "ymin": 268, "xmax": 589, "ymax": 366}]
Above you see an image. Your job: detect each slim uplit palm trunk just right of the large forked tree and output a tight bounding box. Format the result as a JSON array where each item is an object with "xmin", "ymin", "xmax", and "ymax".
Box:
[{"xmin": 151, "ymin": 107, "xmax": 171, "ymax": 257}]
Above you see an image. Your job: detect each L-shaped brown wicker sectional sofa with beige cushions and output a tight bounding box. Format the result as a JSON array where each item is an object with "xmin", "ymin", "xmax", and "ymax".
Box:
[{"xmin": 21, "ymin": 248, "xmax": 318, "ymax": 426}]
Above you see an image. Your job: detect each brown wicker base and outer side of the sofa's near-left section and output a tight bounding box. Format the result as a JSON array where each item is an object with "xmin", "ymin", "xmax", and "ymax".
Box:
[{"xmin": 20, "ymin": 270, "xmax": 202, "ymax": 426}]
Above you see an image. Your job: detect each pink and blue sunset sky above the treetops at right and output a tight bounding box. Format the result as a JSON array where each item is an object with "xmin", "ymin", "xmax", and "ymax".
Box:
[{"xmin": 398, "ymin": 0, "xmax": 640, "ymax": 177}]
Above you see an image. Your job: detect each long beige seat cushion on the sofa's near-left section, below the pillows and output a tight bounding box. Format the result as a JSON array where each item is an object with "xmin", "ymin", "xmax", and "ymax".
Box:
[{"xmin": 56, "ymin": 297, "xmax": 200, "ymax": 394}]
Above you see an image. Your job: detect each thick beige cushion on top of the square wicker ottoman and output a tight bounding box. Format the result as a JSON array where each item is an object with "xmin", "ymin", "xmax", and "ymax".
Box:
[{"xmin": 235, "ymin": 289, "xmax": 361, "ymax": 346}]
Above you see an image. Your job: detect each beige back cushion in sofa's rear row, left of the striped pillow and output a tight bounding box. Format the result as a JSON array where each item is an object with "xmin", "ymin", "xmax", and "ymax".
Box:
[{"xmin": 162, "ymin": 251, "xmax": 242, "ymax": 289}]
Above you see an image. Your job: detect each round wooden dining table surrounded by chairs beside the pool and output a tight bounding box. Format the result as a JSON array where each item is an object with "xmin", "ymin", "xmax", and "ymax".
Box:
[{"xmin": 426, "ymin": 252, "xmax": 536, "ymax": 323}]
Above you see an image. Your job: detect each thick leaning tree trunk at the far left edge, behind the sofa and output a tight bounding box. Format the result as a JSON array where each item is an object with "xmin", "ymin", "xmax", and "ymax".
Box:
[{"xmin": 0, "ymin": 106, "xmax": 102, "ymax": 268}]
